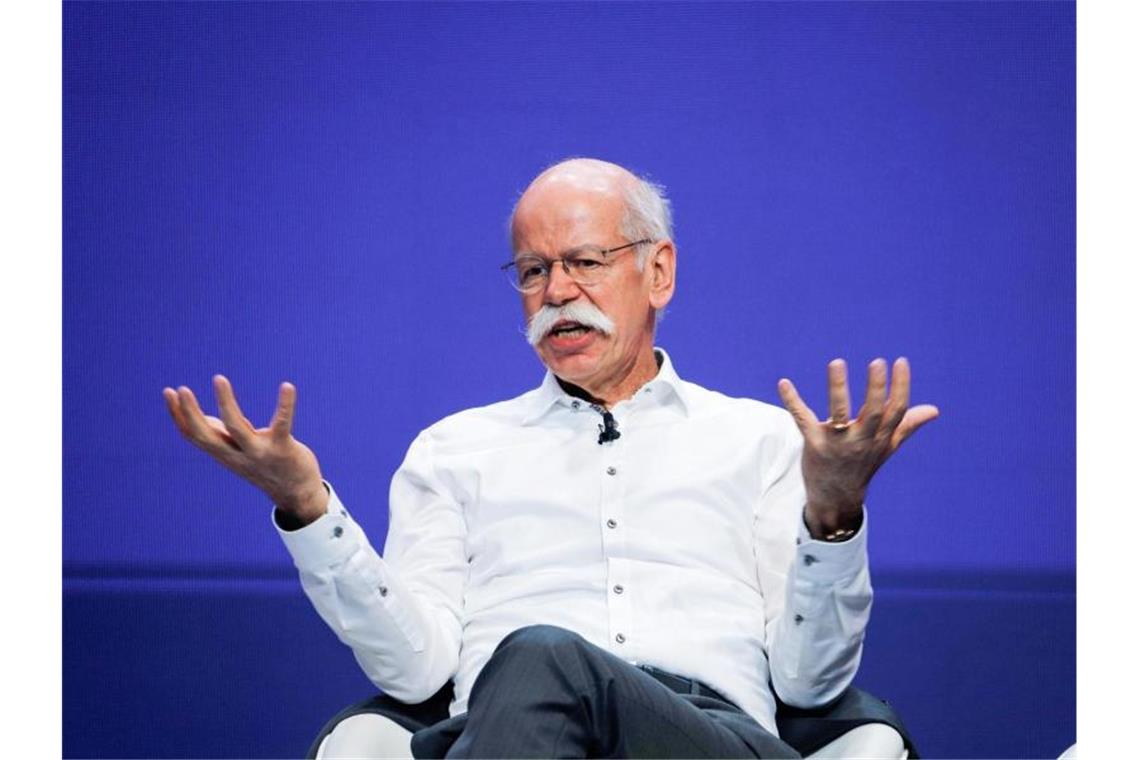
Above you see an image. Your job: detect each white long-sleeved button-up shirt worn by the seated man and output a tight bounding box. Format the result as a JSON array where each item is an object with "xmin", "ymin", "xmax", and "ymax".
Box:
[{"xmin": 278, "ymin": 350, "xmax": 871, "ymax": 733}]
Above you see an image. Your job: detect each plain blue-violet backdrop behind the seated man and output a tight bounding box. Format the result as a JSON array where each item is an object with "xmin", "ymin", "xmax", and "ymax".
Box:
[{"xmin": 63, "ymin": 2, "xmax": 1075, "ymax": 757}]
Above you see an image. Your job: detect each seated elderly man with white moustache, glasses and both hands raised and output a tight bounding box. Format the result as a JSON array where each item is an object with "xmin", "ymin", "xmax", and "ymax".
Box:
[{"xmin": 164, "ymin": 160, "xmax": 937, "ymax": 757}]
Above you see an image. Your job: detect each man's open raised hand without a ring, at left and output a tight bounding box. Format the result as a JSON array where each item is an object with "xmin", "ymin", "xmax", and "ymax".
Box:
[{"xmin": 162, "ymin": 375, "xmax": 328, "ymax": 529}]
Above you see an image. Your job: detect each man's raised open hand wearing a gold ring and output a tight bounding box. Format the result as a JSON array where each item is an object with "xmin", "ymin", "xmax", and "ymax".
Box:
[{"xmin": 776, "ymin": 358, "xmax": 938, "ymax": 538}]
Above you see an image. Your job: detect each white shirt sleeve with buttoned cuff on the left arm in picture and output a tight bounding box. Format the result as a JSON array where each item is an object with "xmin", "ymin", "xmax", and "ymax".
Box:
[{"xmin": 275, "ymin": 432, "xmax": 467, "ymax": 703}]
